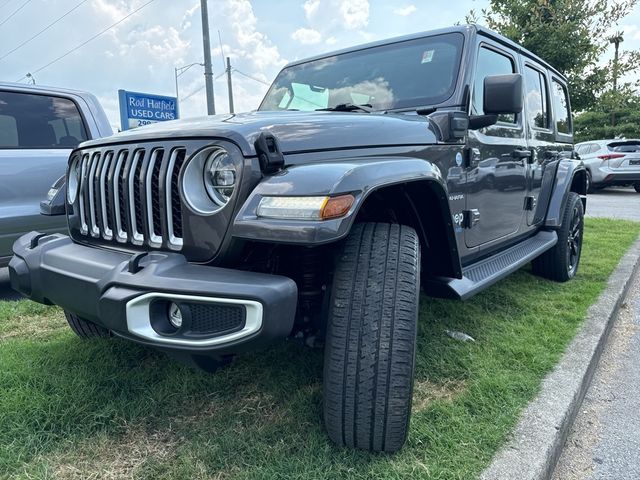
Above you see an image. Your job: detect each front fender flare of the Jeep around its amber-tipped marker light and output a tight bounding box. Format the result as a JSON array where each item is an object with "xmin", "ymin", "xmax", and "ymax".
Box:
[{"xmin": 231, "ymin": 157, "xmax": 459, "ymax": 251}]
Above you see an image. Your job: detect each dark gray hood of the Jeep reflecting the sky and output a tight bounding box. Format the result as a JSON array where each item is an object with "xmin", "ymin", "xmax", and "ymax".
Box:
[{"xmin": 81, "ymin": 111, "xmax": 436, "ymax": 156}]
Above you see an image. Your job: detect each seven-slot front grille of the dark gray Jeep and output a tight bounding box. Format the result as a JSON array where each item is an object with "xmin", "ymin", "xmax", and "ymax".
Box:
[{"xmin": 78, "ymin": 147, "xmax": 186, "ymax": 250}]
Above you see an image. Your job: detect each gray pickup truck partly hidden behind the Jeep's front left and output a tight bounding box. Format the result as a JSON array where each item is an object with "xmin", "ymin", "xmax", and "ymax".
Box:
[{"xmin": 0, "ymin": 83, "xmax": 112, "ymax": 267}]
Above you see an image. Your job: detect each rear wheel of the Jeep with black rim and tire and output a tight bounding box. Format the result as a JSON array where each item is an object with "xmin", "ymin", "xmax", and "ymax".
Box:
[{"xmin": 533, "ymin": 192, "xmax": 584, "ymax": 282}]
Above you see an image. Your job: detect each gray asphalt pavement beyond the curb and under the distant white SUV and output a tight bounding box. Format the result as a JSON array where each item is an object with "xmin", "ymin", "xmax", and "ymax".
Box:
[{"xmin": 553, "ymin": 189, "xmax": 640, "ymax": 480}]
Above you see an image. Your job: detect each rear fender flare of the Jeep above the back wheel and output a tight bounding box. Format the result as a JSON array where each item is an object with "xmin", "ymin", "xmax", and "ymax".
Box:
[{"xmin": 544, "ymin": 159, "xmax": 587, "ymax": 229}]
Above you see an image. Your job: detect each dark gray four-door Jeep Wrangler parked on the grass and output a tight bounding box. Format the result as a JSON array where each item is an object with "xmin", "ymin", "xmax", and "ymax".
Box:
[{"xmin": 10, "ymin": 26, "xmax": 586, "ymax": 452}]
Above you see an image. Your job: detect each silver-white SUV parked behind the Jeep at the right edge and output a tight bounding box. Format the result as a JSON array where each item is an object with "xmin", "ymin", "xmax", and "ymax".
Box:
[{"xmin": 576, "ymin": 140, "xmax": 640, "ymax": 193}]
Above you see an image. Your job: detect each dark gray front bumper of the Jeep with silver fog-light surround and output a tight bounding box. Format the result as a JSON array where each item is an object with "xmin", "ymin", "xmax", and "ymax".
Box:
[{"xmin": 9, "ymin": 232, "xmax": 297, "ymax": 357}]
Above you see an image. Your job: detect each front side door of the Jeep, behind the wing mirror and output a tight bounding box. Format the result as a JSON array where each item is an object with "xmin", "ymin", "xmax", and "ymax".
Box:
[{"xmin": 465, "ymin": 45, "xmax": 527, "ymax": 247}]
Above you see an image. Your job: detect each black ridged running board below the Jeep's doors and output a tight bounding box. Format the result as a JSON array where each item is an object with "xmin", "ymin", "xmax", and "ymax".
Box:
[{"xmin": 425, "ymin": 231, "xmax": 558, "ymax": 300}]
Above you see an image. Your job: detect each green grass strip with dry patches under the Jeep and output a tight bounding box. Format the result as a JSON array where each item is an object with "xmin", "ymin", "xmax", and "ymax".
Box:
[{"xmin": 0, "ymin": 219, "xmax": 640, "ymax": 480}]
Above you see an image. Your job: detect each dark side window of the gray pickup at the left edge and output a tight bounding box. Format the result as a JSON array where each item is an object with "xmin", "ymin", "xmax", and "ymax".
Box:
[{"xmin": 0, "ymin": 92, "xmax": 87, "ymax": 148}]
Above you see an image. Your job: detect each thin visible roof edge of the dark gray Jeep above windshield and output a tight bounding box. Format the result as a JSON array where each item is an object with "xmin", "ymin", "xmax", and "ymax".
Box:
[{"xmin": 284, "ymin": 24, "xmax": 566, "ymax": 82}]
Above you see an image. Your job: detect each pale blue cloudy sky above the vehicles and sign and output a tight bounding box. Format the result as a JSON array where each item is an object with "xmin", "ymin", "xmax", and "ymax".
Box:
[{"xmin": 0, "ymin": 0, "xmax": 640, "ymax": 128}]
